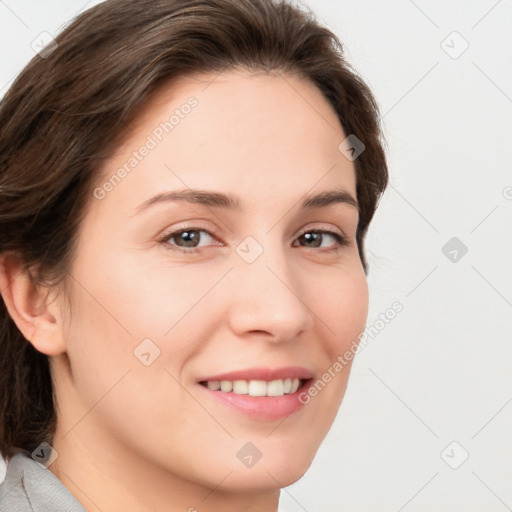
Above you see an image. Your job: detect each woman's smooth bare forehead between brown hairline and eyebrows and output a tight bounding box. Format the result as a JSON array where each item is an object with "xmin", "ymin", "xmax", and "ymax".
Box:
[{"xmin": 91, "ymin": 67, "xmax": 355, "ymax": 213}]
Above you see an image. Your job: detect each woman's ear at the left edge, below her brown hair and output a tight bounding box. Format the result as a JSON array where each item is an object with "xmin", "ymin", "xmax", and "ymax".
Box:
[{"xmin": 0, "ymin": 253, "xmax": 66, "ymax": 356}]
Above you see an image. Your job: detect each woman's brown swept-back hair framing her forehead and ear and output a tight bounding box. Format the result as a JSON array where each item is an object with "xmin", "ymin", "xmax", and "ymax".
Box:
[{"xmin": 0, "ymin": 0, "xmax": 388, "ymax": 457}]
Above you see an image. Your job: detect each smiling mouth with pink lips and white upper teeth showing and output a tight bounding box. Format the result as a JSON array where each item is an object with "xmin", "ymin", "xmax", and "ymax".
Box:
[{"xmin": 198, "ymin": 367, "xmax": 314, "ymax": 421}]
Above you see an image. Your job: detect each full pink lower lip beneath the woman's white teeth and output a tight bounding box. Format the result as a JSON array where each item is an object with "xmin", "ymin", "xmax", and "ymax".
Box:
[{"xmin": 198, "ymin": 379, "xmax": 312, "ymax": 421}]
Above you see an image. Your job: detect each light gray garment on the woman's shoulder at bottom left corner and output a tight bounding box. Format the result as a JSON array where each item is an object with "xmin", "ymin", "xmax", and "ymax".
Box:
[{"xmin": 0, "ymin": 452, "xmax": 86, "ymax": 512}]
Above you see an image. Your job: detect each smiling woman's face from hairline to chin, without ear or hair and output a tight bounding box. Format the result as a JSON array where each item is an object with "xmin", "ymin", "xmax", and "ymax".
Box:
[{"xmin": 52, "ymin": 72, "xmax": 368, "ymax": 490}]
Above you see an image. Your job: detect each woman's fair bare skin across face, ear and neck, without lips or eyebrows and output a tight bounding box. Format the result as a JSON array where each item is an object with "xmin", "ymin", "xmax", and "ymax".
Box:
[{"xmin": 1, "ymin": 70, "xmax": 368, "ymax": 512}]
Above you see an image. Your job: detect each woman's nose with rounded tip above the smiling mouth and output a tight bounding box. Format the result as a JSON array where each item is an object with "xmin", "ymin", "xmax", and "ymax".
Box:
[{"xmin": 229, "ymin": 243, "xmax": 314, "ymax": 343}]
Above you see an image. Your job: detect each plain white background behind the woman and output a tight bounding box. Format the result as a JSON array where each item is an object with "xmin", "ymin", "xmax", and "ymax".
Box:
[{"xmin": 0, "ymin": 0, "xmax": 512, "ymax": 512}]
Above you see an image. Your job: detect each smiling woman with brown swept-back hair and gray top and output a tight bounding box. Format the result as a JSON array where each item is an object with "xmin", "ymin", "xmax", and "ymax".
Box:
[{"xmin": 0, "ymin": 0, "xmax": 387, "ymax": 512}]
